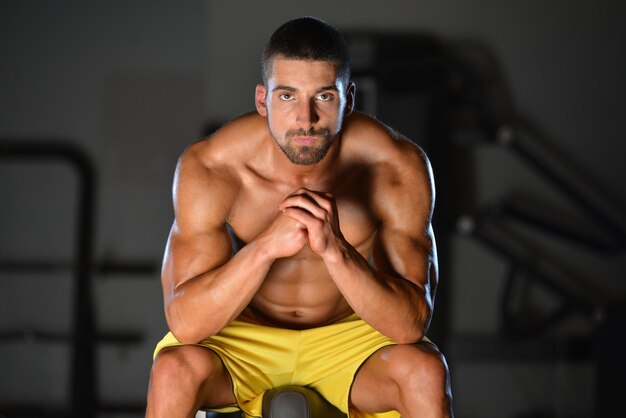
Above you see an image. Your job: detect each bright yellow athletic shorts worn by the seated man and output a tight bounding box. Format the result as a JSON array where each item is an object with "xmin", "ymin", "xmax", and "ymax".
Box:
[{"xmin": 154, "ymin": 314, "xmax": 400, "ymax": 418}]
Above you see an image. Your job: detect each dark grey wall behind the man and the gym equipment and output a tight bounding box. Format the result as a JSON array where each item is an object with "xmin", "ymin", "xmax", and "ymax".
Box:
[{"xmin": 0, "ymin": 0, "xmax": 626, "ymax": 417}]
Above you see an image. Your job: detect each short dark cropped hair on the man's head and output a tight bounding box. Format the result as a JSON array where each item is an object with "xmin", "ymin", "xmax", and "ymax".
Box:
[{"xmin": 261, "ymin": 16, "xmax": 351, "ymax": 85}]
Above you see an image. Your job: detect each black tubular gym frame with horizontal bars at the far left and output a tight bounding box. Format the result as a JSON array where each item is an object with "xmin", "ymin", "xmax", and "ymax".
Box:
[{"xmin": 0, "ymin": 138, "xmax": 158, "ymax": 418}]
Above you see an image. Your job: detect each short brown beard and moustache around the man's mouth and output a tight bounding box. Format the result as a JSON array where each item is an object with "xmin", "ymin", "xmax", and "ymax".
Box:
[{"xmin": 274, "ymin": 128, "xmax": 333, "ymax": 165}]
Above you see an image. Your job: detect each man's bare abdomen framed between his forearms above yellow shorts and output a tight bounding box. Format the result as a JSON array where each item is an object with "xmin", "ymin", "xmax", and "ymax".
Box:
[{"xmin": 239, "ymin": 250, "xmax": 353, "ymax": 329}]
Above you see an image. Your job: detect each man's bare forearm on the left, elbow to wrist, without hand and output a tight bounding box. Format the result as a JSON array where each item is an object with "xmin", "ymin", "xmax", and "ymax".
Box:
[{"xmin": 166, "ymin": 242, "xmax": 274, "ymax": 343}]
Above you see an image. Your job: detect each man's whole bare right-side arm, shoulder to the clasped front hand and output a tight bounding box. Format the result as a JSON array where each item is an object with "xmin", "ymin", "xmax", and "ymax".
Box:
[{"xmin": 281, "ymin": 143, "xmax": 437, "ymax": 343}]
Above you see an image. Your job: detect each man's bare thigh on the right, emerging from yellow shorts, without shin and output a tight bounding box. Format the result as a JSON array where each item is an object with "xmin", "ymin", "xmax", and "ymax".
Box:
[{"xmin": 350, "ymin": 341, "xmax": 446, "ymax": 412}]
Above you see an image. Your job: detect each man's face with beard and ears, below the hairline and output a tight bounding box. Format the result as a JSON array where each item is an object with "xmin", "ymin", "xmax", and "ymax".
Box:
[{"xmin": 256, "ymin": 58, "xmax": 354, "ymax": 165}]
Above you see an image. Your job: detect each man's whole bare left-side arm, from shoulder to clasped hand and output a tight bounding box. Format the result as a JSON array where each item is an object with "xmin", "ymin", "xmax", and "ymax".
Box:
[{"xmin": 161, "ymin": 144, "xmax": 306, "ymax": 343}]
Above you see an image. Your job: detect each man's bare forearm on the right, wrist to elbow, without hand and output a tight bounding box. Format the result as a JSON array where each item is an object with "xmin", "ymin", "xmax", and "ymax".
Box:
[{"xmin": 323, "ymin": 243, "xmax": 432, "ymax": 343}]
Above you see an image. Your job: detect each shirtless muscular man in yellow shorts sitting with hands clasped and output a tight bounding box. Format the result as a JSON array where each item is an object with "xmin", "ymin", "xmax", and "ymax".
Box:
[{"xmin": 147, "ymin": 18, "xmax": 452, "ymax": 418}]
